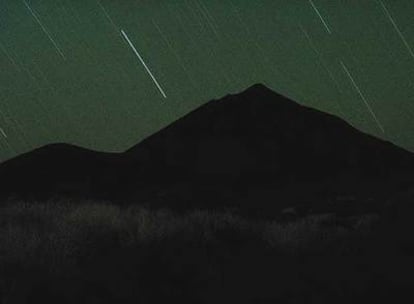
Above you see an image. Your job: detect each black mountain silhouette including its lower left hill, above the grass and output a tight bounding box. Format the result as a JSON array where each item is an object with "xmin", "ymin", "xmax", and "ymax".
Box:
[{"xmin": 0, "ymin": 84, "xmax": 414, "ymax": 213}]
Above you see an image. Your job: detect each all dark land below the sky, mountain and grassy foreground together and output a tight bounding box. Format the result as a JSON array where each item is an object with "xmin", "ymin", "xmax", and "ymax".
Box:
[{"xmin": 0, "ymin": 85, "xmax": 414, "ymax": 304}]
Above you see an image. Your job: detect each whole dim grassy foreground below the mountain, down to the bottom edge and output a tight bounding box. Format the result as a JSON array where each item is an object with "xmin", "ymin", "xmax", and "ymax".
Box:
[{"xmin": 0, "ymin": 200, "xmax": 410, "ymax": 303}]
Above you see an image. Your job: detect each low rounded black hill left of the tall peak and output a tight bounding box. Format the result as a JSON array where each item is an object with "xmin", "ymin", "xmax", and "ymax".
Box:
[{"xmin": 0, "ymin": 144, "xmax": 122, "ymax": 199}]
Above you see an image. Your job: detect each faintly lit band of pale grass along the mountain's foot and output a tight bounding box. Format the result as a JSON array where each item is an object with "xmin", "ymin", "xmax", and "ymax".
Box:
[{"xmin": 0, "ymin": 201, "xmax": 376, "ymax": 266}]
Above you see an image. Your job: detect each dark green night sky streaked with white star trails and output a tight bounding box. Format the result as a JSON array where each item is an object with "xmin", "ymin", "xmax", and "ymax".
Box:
[{"xmin": 0, "ymin": 0, "xmax": 414, "ymax": 160}]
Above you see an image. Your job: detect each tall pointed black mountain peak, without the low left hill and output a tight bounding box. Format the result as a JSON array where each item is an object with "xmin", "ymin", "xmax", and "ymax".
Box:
[{"xmin": 119, "ymin": 84, "xmax": 414, "ymax": 214}]
